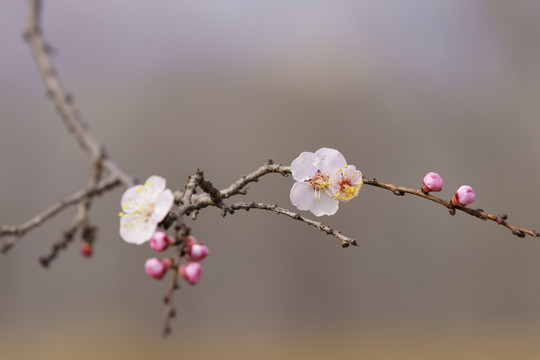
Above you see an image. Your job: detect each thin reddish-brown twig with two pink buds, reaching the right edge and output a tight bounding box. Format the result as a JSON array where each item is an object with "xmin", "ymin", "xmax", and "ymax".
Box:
[{"xmin": 363, "ymin": 177, "xmax": 540, "ymax": 237}]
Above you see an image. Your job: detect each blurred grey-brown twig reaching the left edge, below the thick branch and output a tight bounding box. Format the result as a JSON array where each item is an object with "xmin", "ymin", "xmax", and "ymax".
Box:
[{"xmin": 0, "ymin": 177, "xmax": 122, "ymax": 253}]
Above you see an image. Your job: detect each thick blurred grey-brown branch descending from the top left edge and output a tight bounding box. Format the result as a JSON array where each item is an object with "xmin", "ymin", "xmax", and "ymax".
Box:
[{"xmin": 24, "ymin": 0, "xmax": 135, "ymax": 187}]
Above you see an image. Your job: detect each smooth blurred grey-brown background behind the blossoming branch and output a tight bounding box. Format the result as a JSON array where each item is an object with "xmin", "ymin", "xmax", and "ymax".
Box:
[{"xmin": 0, "ymin": 0, "xmax": 540, "ymax": 359}]
